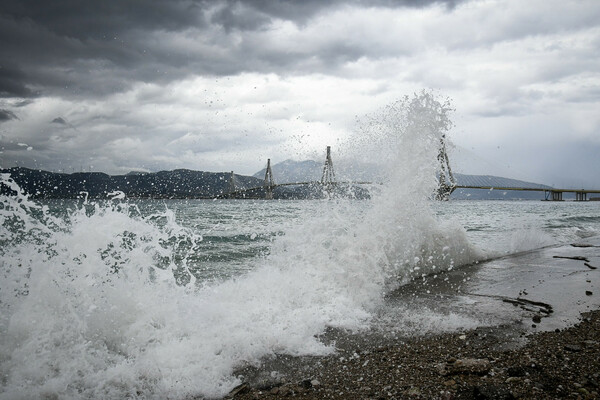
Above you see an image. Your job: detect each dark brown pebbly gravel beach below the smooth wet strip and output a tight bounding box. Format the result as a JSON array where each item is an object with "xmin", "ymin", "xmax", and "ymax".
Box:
[{"xmin": 227, "ymin": 311, "xmax": 600, "ymax": 400}]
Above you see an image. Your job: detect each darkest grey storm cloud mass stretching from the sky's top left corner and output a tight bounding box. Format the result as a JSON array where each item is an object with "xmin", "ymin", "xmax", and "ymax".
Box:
[{"xmin": 0, "ymin": 0, "xmax": 456, "ymax": 98}]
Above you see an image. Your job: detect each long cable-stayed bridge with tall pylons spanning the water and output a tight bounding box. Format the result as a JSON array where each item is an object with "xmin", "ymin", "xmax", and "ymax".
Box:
[{"xmin": 218, "ymin": 141, "xmax": 600, "ymax": 201}]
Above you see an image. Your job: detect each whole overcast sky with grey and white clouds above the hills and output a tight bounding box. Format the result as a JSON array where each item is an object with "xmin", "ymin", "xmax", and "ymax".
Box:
[{"xmin": 0, "ymin": 0, "xmax": 600, "ymax": 189}]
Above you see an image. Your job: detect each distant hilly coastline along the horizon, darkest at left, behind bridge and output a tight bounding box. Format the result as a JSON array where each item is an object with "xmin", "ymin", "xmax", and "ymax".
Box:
[{"xmin": 0, "ymin": 164, "xmax": 550, "ymax": 200}]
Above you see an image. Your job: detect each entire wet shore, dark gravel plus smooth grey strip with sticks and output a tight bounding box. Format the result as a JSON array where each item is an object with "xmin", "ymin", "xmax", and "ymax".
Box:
[{"xmin": 228, "ymin": 238, "xmax": 600, "ymax": 400}]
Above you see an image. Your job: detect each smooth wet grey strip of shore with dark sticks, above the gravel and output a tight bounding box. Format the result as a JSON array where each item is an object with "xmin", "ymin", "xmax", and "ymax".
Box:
[{"xmin": 382, "ymin": 237, "xmax": 600, "ymax": 334}]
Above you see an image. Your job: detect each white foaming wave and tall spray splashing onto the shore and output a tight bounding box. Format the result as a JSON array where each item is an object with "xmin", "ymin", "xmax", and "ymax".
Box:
[{"xmin": 0, "ymin": 93, "xmax": 477, "ymax": 399}]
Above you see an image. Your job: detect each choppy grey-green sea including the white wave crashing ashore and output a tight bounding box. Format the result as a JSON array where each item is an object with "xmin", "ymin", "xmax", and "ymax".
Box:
[{"xmin": 0, "ymin": 94, "xmax": 600, "ymax": 399}]
